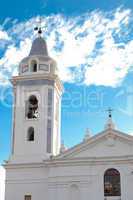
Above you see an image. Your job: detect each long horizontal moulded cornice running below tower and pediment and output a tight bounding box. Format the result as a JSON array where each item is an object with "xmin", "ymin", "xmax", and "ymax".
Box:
[{"xmin": 3, "ymin": 155, "xmax": 133, "ymax": 169}]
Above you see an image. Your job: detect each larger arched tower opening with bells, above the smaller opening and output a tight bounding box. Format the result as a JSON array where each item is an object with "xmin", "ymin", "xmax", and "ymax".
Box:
[{"xmin": 26, "ymin": 95, "xmax": 38, "ymax": 119}]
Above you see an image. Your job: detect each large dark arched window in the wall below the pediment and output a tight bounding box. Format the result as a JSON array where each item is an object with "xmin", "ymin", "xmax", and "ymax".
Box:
[{"xmin": 104, "ymin": 169, "xmax": 121, "ymax": 197}]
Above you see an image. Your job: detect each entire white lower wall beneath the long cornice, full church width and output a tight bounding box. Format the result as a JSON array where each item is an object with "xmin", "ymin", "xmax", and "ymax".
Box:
[{"xmin": 4, "ymin": 161, "xmax": 133, "ymax": 200}]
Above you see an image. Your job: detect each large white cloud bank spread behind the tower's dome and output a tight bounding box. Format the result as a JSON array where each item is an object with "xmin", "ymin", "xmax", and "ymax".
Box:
[{"xmin": 0, "ymin": 9, "xmax": 133, "ymax": 87}]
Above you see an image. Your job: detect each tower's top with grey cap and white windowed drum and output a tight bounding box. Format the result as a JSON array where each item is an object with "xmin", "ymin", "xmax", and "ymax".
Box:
[{"xmin": 19, "ymin": 36, "xmax": 58, "ymax": 76}]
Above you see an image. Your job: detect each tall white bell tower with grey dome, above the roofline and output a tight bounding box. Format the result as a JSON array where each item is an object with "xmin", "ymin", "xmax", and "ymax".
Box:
[{"xmin": 10, "ymin": 36, "xmax": 63, "ymax": 163}]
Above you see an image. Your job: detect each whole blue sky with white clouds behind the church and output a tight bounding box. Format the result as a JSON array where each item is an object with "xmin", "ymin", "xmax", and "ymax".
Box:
[{"xmin": 0, "ymin": 0, "xmax": 133, "ymax": 161}]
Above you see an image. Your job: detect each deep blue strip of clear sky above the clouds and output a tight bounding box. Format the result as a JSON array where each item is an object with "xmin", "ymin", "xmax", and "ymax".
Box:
[{"xmin": 0, "ymin": 0, "xmax": 133, "ymax": 21}]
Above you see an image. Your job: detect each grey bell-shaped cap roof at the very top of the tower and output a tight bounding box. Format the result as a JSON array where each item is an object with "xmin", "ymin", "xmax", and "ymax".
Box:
[{"xmin": 29, "ymin": 37, "xmax": 48, "ymax": 56}]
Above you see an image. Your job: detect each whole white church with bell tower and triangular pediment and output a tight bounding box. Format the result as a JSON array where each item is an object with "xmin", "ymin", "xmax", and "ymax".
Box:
[{"xmin": 4, "ymin": 28, "xmax": 133, "ymax": 200}]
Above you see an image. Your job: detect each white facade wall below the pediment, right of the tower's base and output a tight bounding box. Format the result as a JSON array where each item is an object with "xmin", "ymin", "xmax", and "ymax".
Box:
[{"xmin": 48, "ymin": 162, "xmax": 133, "ymax": 200}]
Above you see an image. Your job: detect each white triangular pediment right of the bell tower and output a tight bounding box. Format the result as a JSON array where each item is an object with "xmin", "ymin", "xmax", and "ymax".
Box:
[{"xmin": 57, "ymin": 129, "xmax": 133, "ymax": 159}]
